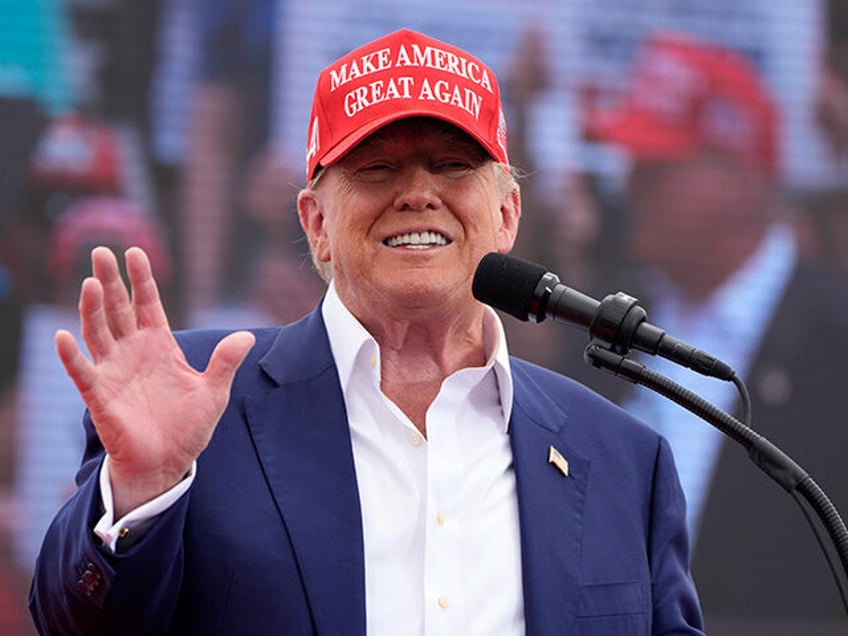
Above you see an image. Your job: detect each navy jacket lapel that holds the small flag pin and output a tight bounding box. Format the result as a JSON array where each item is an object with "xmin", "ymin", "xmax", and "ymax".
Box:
[{"xmin": 510, "ymin": 368, "xmax": 590, "ymax": 635}]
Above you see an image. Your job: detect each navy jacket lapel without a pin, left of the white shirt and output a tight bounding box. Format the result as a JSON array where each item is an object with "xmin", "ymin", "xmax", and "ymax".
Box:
[{"xmin": 246, "ymin": 311, "xmax": 365, "ymax": 635}]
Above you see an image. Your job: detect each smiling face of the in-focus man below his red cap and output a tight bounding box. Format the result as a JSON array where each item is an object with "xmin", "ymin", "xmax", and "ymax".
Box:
[{"xmin": 298, "ymin": 118, "xmax": 520, "ymax": 313}]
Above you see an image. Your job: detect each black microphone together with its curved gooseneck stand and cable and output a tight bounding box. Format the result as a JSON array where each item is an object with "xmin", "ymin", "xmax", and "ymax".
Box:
[{"xmin": 471, "ymin": 252, "xmax": 848, "ymax": 613}]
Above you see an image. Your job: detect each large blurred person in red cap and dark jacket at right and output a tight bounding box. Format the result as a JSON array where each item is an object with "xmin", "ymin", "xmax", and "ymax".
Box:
[{"xmin": 586, "ymin": 33, "xmax": 848, "ymax": 634}]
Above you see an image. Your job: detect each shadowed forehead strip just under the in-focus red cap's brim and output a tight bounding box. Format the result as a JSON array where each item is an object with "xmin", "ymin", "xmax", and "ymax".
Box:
[{"xmin": 346, "ymin": 117, "xmax": 488, "ymax": 160}]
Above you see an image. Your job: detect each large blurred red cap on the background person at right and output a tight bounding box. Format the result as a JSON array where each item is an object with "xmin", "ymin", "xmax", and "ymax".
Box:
[{"xmin": 585, "ymin": 33, "xmax": 779, "ymax": 174}]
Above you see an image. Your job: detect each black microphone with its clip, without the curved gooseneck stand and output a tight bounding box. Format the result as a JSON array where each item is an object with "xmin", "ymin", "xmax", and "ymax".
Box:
[{"xmin": 471, "ymin": 252, "xmax": 736, "ymax": 381}]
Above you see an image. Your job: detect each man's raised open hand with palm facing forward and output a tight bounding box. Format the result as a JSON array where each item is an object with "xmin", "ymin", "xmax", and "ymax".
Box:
[{"xmin": 56, "ymin": 247, "xmax": 255, "ymax": 519}]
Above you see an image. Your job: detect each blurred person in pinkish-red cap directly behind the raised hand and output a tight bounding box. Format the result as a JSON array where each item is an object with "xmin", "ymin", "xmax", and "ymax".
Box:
[{"xmin": 12, "ymin": 196, "xmax": 171, "ymax": 576}]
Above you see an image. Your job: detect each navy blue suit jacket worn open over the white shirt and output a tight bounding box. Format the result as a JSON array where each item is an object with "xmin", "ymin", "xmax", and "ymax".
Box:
[{"xmin": 30, "ymin": 311, "xmax": 701, "ymax": 636}]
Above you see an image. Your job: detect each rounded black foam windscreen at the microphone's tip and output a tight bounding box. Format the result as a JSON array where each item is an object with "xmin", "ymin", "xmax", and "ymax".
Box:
[{"xmin": 471, "ymin": 252, "xmax": 547, "ymax": 320}]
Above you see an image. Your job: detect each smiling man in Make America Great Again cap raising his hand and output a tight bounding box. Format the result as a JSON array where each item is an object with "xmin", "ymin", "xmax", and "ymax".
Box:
[{"xmin": 31, "ymin": 30, "xmax": 700, "ymax": 635}]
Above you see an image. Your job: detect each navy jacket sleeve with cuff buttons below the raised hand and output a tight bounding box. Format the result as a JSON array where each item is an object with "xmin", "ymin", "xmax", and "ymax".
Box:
[{"xmin": 29, "ymin": 417, "xmax": 188, "ymax": 636}]
